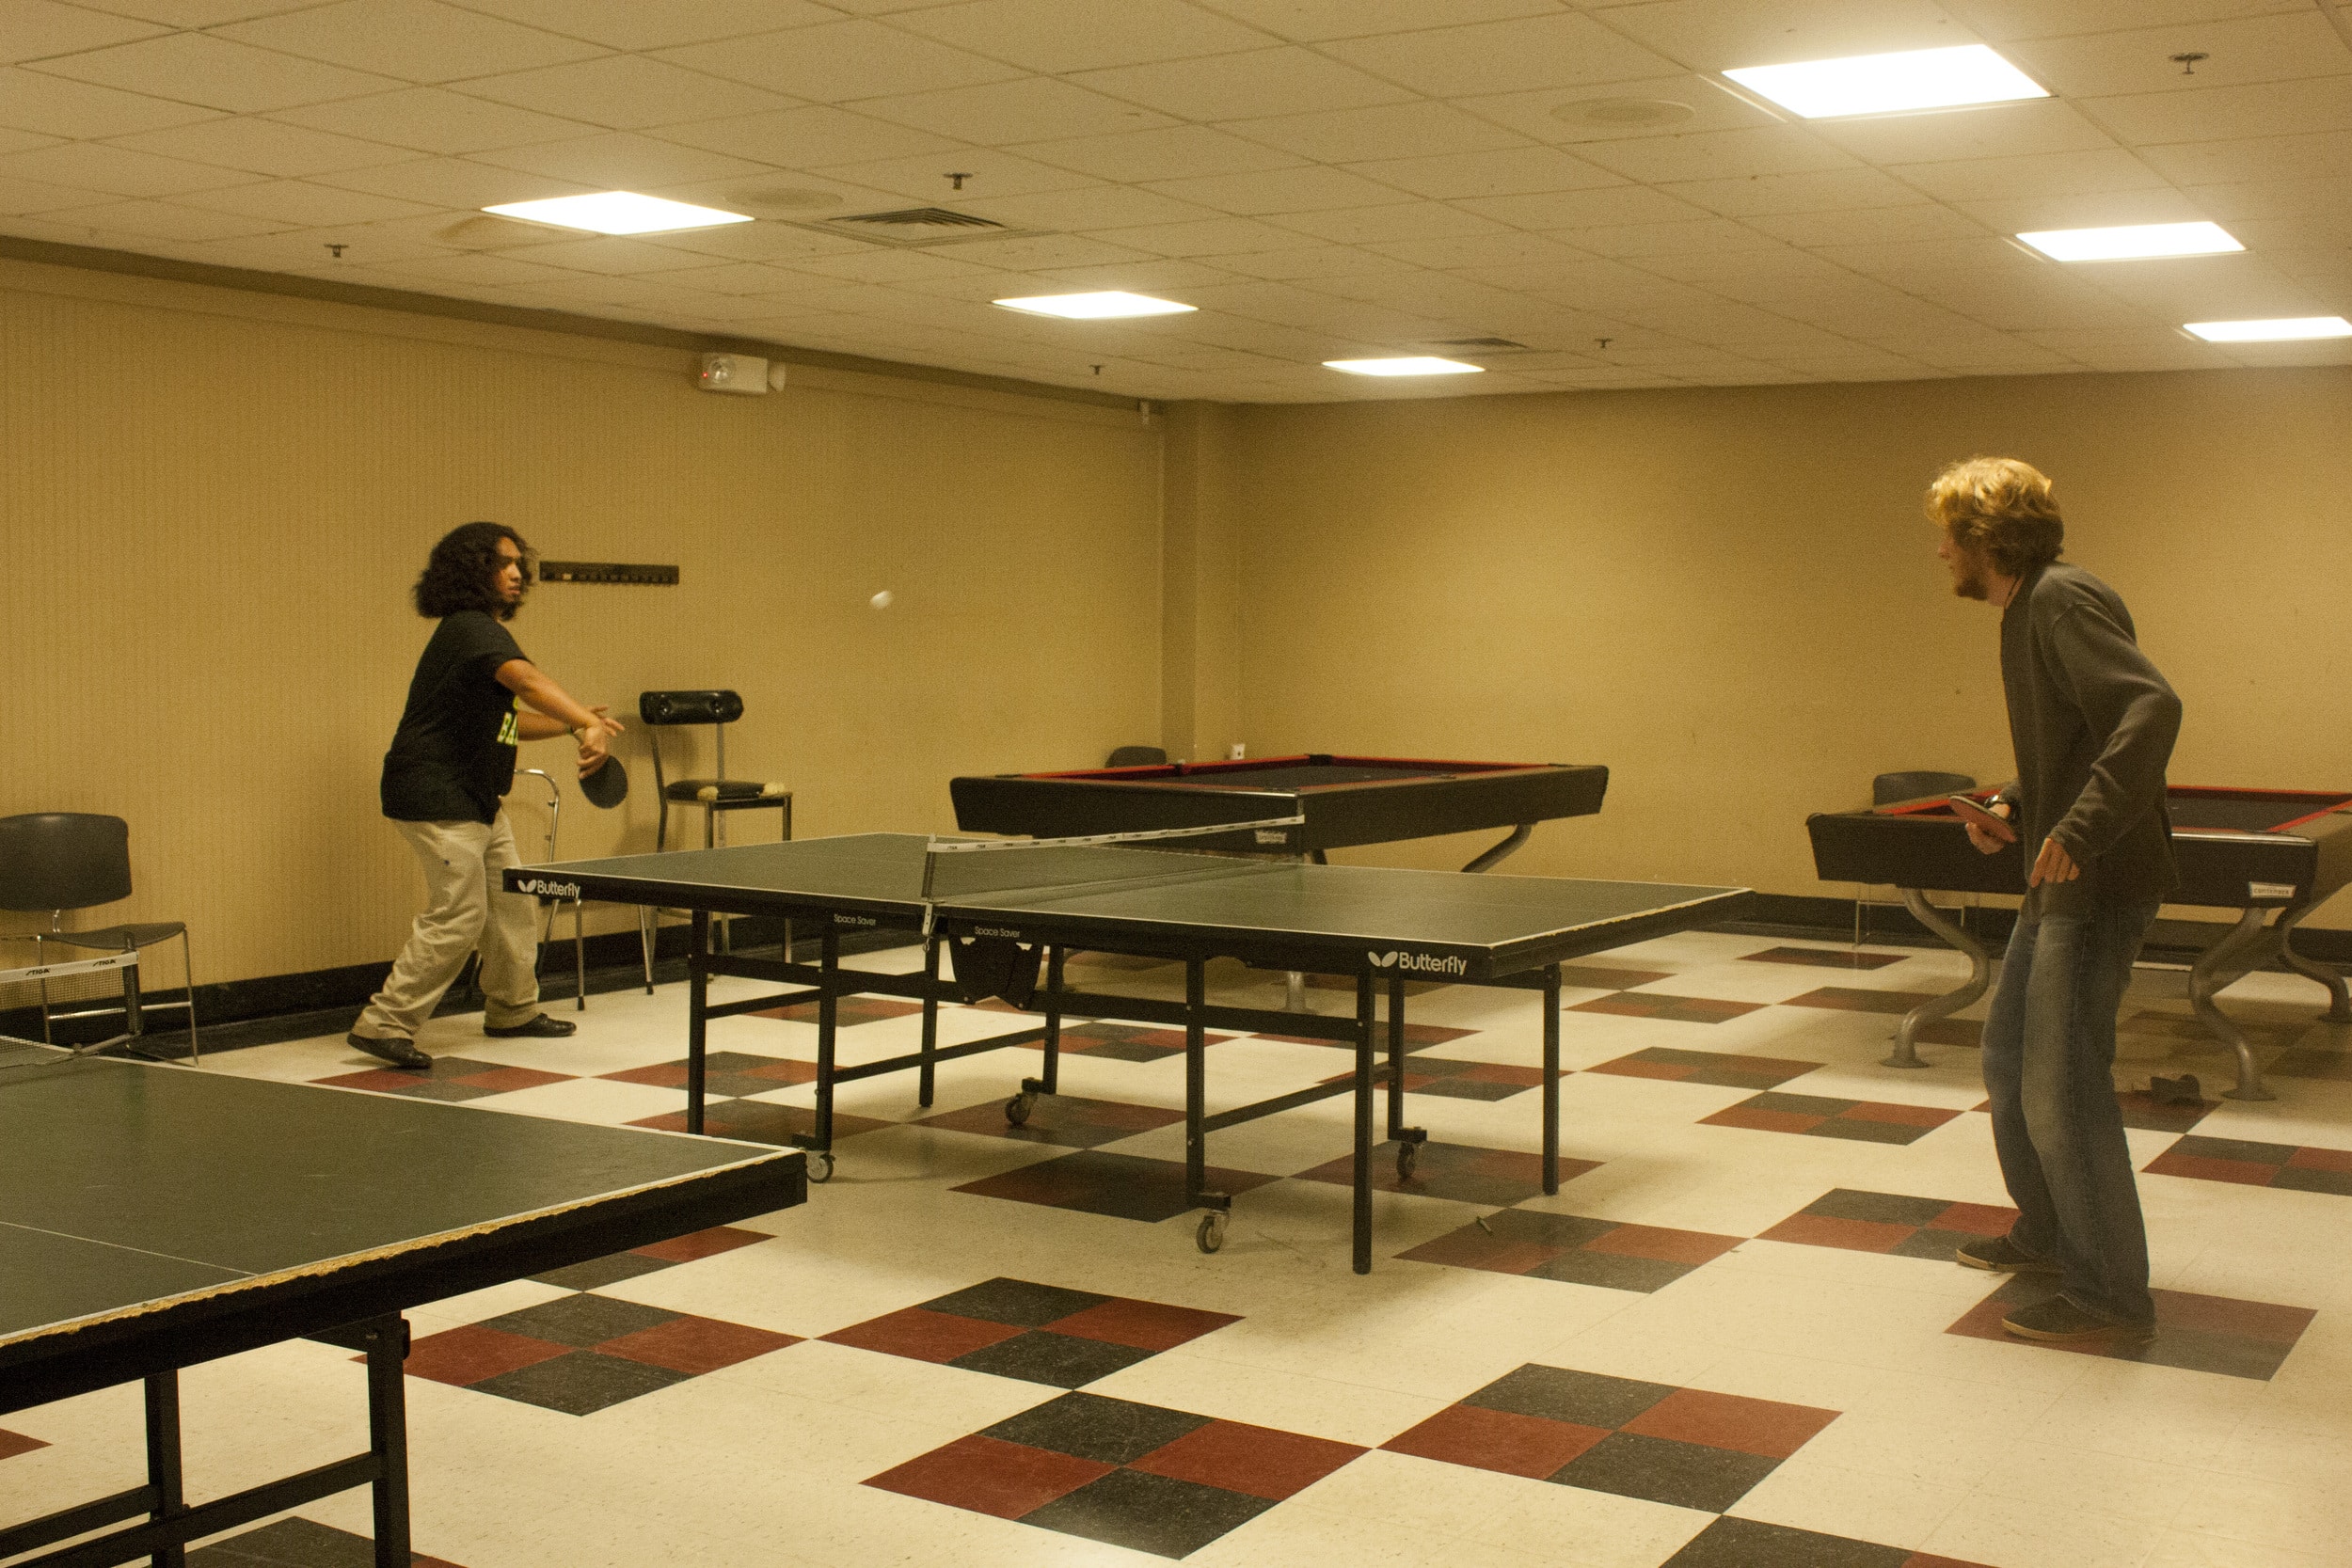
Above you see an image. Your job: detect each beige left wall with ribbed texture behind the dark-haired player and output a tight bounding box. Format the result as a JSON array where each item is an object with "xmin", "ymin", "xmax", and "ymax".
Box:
[{"xmin": 0, "ymin": 263, "xmax": 1160, "ymax": 980}]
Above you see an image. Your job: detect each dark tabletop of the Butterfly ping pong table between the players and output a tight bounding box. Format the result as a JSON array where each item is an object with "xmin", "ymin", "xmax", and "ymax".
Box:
[{"xmin": 506, "ymin": 832, "xmax": 1750, "ymax": 980}]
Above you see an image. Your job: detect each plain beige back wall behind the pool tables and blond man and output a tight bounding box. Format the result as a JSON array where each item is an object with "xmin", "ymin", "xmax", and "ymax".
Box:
[{"xmin": 1237, "ymin": 369, "xmax": 2352, "ymax": 924}]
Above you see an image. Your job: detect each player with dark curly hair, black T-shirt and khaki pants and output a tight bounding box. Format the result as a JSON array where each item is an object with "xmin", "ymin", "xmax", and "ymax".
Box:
[{"xmin": 351, "ymin": 522, "xmax": 621, "ymax": 1068}]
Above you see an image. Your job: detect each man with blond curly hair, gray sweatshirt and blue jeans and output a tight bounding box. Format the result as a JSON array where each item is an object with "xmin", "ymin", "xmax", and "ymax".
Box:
[{"xmin": 1927, "ymin": 458, "xmax": 2181, "ymax": 1342}]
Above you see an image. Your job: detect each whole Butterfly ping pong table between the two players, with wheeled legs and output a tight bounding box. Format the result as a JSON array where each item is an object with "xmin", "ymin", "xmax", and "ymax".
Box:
[{"xmin": 506, "ymin": 823, "xmax": 1750, "ymax": 1275}]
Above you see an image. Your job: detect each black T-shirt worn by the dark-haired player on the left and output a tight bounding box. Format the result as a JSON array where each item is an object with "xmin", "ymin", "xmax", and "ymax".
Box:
[{"xmin": 384, "ymin": 609, "xmax": 522, "ymax": 823}]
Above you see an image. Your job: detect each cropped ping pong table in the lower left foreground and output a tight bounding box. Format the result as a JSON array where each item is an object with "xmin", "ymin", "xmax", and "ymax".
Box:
[{"xmin": 0, "ymin": 1046, "xmax": 807, "ymax": 1568}]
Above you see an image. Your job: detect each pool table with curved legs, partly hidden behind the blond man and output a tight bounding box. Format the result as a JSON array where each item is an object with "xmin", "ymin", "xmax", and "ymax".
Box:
[{"xmin": 1804, "ymin": 785, "xmax": 2352, "ymax": 1101}]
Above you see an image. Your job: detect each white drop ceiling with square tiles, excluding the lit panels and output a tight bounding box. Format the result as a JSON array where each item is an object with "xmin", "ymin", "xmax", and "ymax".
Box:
[{"xmin": 0, "ymin": 0, "xmax": 2352, "ymax": 400}]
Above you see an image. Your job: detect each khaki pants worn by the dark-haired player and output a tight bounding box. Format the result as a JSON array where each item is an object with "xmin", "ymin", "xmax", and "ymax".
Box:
[{"xmin": 353, "ymin": 811, "xmax": 539, "ymax": 1039}]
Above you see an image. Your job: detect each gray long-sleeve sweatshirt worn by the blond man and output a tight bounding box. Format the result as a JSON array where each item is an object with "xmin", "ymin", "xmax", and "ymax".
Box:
[{"xmin": 2002, "ymin": 562, "xmax": 2181, "ymax": 912}]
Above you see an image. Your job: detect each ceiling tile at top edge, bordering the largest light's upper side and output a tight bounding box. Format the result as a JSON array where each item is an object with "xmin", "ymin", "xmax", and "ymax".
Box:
[{"xmin": 1607, "ymin": 0, "xmax": 1976, "ymax": 71}]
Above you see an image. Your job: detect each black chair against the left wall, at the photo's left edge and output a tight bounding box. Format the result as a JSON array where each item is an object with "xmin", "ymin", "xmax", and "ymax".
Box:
[{"xmin": 0, "ymin": 811, "xmax": 205, "ymax": 1063}]
